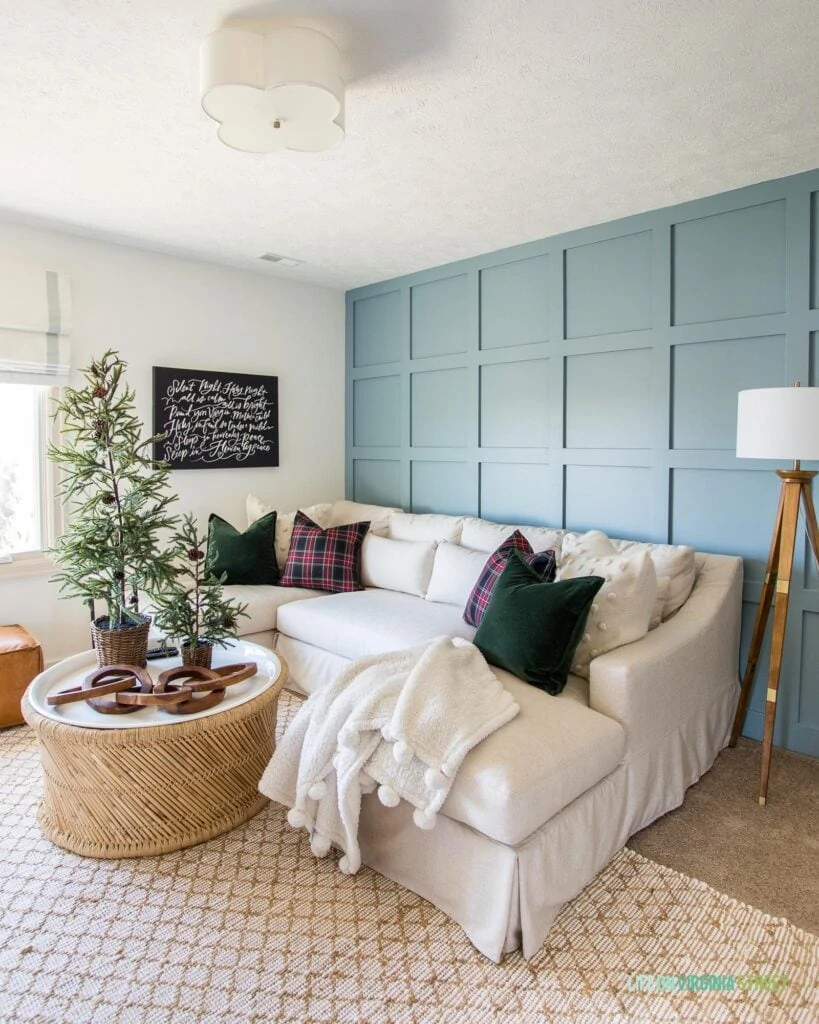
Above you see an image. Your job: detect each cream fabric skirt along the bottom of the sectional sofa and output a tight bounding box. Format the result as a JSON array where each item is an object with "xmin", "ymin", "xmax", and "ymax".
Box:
[{"xmin": 261, "ymin": 635, "xmax": 738, "ymax": 963}]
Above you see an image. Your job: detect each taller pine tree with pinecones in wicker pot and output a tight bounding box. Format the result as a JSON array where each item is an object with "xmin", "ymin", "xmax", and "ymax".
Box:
[{"xmin": 48, "ymin": 349, "xmax": 178, "ymax": 666}]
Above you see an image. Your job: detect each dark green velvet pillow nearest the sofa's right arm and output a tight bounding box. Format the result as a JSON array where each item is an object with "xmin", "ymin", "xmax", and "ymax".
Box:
[{"xmin": 474, "ymin": 551, "xmax": 604, "ymax": 694}]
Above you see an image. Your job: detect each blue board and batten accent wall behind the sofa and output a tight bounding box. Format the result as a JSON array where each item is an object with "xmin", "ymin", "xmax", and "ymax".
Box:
[{"xmin": 347, "ymin": 171, "xmax": 819, "ymax": 756}]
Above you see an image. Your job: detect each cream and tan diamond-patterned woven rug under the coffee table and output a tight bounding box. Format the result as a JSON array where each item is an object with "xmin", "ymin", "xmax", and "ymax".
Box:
[{"xmin": 0, "ymin": 698, "xmax": 819, "ymax": 1024}]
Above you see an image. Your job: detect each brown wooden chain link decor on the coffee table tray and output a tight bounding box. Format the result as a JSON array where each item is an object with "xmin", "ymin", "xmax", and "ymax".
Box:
[{"xmin": 46, "ymin": 662, "xmax": 257, "ymax": 715}]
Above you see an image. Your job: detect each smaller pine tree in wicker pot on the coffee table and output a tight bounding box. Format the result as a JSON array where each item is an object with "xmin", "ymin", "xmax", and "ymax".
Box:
[{"xmin": 153, "ymin": 515, "xmax": 247, "ymax": 668}]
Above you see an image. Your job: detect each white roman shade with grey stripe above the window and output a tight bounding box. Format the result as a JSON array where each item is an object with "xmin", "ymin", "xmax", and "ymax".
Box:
[{"xmin": 0, "ymin": 259, "xmax": 71, "ymax": 386}]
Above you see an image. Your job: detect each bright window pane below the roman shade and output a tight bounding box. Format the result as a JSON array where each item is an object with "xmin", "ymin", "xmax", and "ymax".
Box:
[{"xmin": 0, "ymin": 384, "xmax": 55, "ymax": 562}]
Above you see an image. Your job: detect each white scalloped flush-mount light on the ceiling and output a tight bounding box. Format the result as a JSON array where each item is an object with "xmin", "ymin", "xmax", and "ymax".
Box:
[{"xmin": 200, "ymin": 26, "xmax": 344, "ymax": 153}]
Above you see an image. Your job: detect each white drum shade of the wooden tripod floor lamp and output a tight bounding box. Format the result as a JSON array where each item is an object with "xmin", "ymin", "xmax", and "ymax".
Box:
[{"xmin": 736, "ymin": 387, "xmax": 819, "ymax": 461}]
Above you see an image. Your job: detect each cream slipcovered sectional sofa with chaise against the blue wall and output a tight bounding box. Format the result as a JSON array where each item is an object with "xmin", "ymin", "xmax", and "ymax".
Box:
[{"xmin": 226, "ymin": 499, "xmax": 742, "ymax": 962}]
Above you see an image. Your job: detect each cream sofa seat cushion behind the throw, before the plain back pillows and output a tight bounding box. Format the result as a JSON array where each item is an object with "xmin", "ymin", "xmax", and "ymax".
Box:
[{"xmin": 278, "ymin": 590, "xmax": 475, "ymax": 658}]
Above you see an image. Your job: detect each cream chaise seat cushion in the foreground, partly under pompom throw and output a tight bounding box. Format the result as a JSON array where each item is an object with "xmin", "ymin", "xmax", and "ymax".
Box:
[{"xmin": 442, "ymin": 667, "xmax": 626, "ymax": 846}]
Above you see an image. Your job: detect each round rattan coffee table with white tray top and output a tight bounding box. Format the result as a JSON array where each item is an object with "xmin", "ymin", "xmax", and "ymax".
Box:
[{"xmin": 23, "ymin": 640, "xmax": 287, "ymax": 857}]
